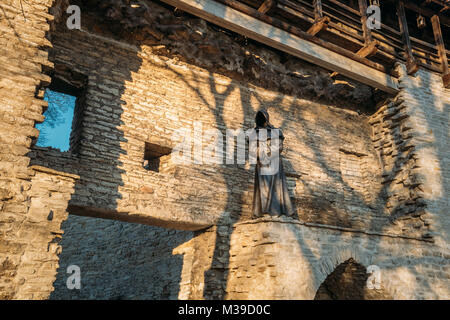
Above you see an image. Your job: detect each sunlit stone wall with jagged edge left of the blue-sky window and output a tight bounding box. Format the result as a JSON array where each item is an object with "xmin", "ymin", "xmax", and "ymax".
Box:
[{"xmin": 0, "ymin": 0, "xmax": 59, "ymax": 299}]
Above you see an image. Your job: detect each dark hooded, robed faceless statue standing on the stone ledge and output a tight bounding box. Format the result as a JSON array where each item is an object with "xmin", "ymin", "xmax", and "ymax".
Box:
[{"xmin": 249, "ymin": 110, "xmax": 294, "ymax": 218}]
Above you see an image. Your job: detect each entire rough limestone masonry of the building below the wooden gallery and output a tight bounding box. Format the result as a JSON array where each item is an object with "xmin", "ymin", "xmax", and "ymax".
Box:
[{"xmin": 0, "ymin": 0, "xmax": 450, "ymax": 299}]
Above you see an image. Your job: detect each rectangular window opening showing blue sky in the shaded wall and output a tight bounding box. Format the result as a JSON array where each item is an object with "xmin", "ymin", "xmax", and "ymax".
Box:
[{"xmin": 36, "ymin": 67, "xmax": 87, "ymax": 153}]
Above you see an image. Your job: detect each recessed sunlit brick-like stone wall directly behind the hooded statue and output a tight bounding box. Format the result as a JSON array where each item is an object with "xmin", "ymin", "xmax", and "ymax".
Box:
[{"xmin": 30, "ymin": 4, "xmax": 387, "ymax": 230}]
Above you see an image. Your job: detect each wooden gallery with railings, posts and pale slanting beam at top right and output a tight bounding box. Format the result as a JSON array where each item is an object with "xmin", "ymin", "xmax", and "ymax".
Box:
[{"xmin": 162, "ymin": 0, "xmax": 450, "ymax": 92}]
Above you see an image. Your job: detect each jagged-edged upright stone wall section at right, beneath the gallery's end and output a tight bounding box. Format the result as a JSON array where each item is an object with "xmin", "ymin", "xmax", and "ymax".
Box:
[{"xmin": 369, "ymin": 66, "xmax": 450, "ymax": 245}]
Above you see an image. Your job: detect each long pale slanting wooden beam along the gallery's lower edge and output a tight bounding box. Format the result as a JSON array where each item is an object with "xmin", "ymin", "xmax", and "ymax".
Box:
[{"xmin": 163, "ymin": 0, "xmax": 398, "ymax": 94}]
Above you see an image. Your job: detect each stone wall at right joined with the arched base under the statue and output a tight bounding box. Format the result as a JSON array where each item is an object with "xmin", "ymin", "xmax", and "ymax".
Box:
[{"xmin": 171, "ymin": 66, "xmax": 450, "ymax": 299}]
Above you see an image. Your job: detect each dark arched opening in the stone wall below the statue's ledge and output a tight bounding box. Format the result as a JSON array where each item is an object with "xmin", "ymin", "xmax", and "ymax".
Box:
[{"xmin": 314, "ymin": 258, "xmax": 392, "ymax": 300}]
